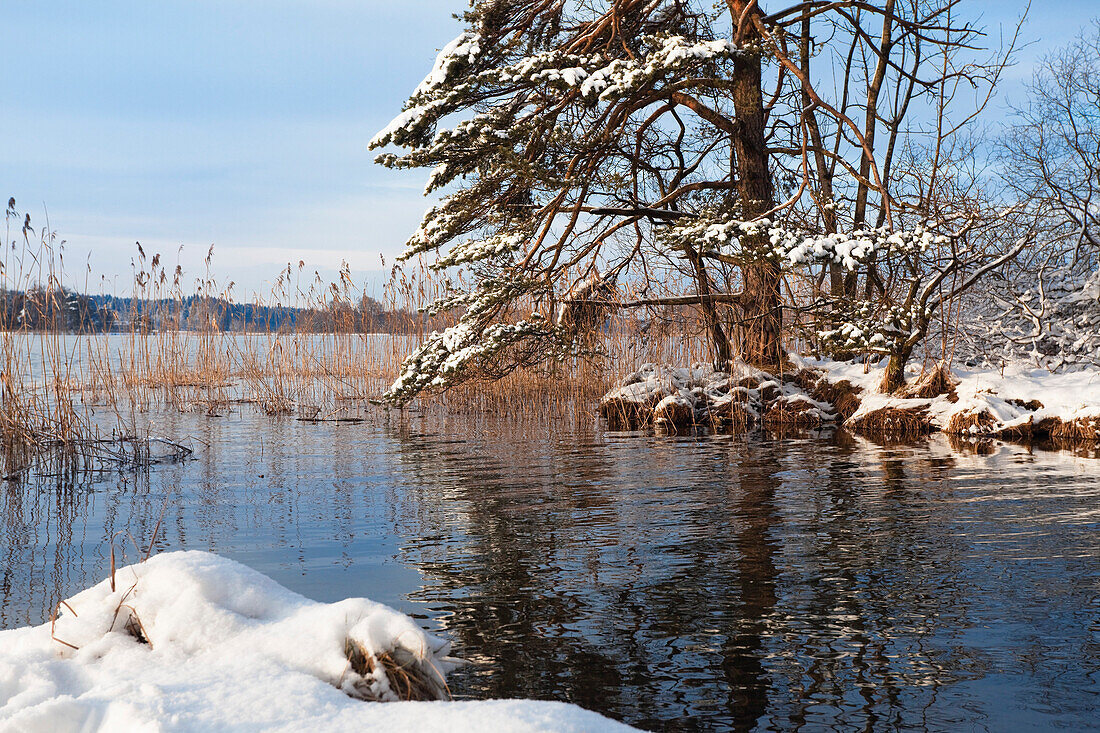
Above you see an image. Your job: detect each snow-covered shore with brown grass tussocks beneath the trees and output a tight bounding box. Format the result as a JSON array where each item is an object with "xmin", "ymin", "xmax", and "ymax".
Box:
[{"xmin": 600, "ymin": 357, "xmax": 1100, "ymax": 442}]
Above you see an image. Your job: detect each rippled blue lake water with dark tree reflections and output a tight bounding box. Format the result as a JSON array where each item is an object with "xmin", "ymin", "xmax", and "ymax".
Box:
[{"xmin": 0, "ymin": 408, "xmax": 1100, "ymax": 731}]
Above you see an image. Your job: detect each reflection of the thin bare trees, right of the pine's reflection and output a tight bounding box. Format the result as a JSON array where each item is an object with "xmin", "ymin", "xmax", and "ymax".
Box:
[{"xmin": 730, "ymin": 434, "xmax": 981, "ymax": 730}]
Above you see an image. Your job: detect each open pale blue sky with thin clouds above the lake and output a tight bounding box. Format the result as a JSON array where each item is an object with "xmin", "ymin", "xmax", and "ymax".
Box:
[{"xmin": 0, "ymin": 0, "xmax": 1100, "ymax": 297}]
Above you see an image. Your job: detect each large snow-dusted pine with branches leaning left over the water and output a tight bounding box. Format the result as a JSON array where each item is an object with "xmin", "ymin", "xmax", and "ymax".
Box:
[{"xmin": 371, "ymin": 0, "xmax": 1012, "ymax": 403}]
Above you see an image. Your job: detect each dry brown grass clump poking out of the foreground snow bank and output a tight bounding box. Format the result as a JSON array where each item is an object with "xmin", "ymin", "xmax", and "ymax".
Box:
[{"xmin": 340, "ymin": 638, "xmax": 451, "ymax": 702}]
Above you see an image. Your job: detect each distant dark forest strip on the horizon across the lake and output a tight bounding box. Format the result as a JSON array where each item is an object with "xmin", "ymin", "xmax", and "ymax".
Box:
[{"xmin": 0, "ymin": 288, "xmax": 427, "ymax": 333}]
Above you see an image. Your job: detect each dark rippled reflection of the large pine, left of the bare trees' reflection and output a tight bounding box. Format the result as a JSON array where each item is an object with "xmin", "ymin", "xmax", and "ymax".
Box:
[{"xmin": 387, "ymin": 420, "xmax": 792, "ymax": 729}]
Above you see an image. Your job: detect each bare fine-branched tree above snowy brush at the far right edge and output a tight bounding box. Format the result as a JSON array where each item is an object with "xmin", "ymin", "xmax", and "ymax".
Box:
[{"xmin": 966, "ymin": 21, "xmax": 1100, "ymax": 369}]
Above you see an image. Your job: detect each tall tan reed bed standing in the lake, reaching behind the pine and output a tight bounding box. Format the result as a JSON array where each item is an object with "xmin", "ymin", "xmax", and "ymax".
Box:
[{"xmin": 0, "ymin": 202, "xmax": 726, "ymax": 475}]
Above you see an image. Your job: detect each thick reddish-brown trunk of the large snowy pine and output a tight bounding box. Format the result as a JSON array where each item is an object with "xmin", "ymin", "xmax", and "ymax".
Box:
[{"xmin": 726, "ymin": 0, "xmax": 785, "ymax": 369}]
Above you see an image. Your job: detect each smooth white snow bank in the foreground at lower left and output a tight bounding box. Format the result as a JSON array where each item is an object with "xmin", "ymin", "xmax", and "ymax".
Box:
[{"xmin": 0, "ymin": 553, "xmax": 631, "ymax": 732}]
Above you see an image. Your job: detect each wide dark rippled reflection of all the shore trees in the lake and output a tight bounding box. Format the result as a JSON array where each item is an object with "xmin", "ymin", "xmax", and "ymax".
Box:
[{"xmin": 394, "ymin": 422, "xmax": 1064, "ymax": 730}]
